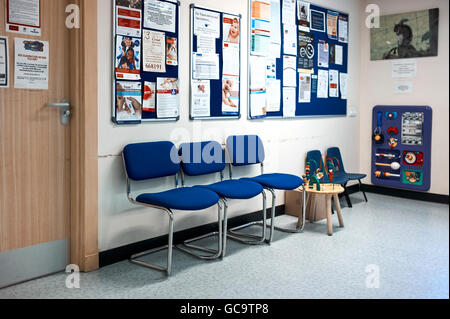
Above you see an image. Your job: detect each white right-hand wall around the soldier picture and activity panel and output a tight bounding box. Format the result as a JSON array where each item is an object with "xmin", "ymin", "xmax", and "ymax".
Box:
[{"xmin": 360, "ymin": 0, "xmax": 449, "ymax": 195}]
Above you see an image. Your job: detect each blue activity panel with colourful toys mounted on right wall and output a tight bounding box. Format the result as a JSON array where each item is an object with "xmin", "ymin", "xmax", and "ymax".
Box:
[{"xmin": 372, "ymin": 106, "xmax": 433, "ymax": 191}]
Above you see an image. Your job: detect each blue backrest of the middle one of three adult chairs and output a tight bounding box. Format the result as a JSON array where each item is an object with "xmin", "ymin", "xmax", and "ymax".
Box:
[{"xmin": 179, "ymin": 141, "xmax": 226, "ymax": 176}]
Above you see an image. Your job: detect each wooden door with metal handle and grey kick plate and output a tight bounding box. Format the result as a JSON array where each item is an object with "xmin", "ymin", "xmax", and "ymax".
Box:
[{"xmin": 0, "ymin": 0, "xmax": 71, "ymax": 287}]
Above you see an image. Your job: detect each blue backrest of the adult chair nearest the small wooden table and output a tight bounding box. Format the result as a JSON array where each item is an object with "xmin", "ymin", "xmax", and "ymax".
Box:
[{"xmin": 227, "ymin": 135, "xmax": 266, "ymax": 166}]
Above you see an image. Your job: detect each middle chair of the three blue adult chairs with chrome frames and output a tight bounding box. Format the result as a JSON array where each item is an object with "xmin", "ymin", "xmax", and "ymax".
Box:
[{"xmin": 178, "ymin": 141, "xmax": 266, "ymax": 258}]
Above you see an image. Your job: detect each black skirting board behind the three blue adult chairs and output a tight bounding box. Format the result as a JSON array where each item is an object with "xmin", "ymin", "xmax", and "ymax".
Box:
[{"xmin": 99, "ymin": 205, "xmax": 285, "ymax": 267}]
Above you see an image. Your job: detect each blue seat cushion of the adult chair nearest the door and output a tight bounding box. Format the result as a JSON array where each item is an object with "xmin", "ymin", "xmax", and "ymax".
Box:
[{"xmin": 136, "ymin": 187, "xmax": 220, "ymax": 210}]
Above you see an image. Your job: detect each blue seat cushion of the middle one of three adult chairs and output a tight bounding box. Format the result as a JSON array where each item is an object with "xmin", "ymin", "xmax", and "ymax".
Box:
[{"xmin": 197, "ymin": 180, "xmax": 264, "ymax": 199}]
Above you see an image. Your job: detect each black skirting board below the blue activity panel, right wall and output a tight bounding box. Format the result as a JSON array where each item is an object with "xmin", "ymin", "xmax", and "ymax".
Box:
[{"xmin": 347, "ymin": 184, "xmax": 449, "ymax": 205}]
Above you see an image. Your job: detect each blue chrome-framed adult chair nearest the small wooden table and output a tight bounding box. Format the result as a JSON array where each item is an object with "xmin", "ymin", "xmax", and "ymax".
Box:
[{"xmin": 227, "ymin": 135, "xmax": 306, "ymax": 244}]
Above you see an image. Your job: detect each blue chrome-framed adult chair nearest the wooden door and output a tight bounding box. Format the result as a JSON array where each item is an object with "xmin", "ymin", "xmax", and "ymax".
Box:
[{"xmin": 122, "ymin": 142, "xmax": 222, "ymax": 276}]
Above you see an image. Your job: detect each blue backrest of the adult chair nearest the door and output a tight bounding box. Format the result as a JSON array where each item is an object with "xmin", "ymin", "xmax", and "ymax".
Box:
[{"xmin": 123, "ymin": 142, "xmax": 180, "ymax": 181}]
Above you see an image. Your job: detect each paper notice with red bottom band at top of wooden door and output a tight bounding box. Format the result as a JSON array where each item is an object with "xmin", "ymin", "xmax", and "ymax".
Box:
[{"xmin": 6, "ymin": 0, "xmax": 41, "ymax": 36}]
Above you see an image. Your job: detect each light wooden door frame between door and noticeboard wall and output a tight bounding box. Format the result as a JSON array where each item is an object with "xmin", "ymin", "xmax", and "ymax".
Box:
[{"xmin": 70, "ymin": 0, "xmax": 99, "ymax": 272}]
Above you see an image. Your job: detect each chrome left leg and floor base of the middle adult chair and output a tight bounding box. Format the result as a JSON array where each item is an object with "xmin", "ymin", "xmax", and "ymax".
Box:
[{"xmin": 176, "ymin": 202, "xmax": 223, "ymax": 260}]
